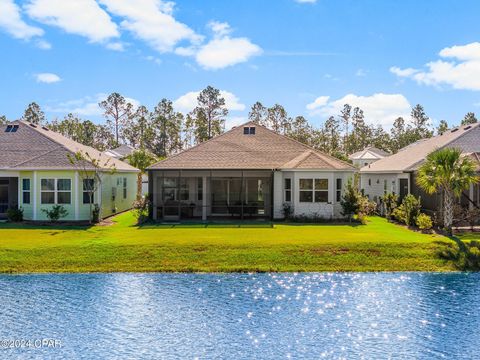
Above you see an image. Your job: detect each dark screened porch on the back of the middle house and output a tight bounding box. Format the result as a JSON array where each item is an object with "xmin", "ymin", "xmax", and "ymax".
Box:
[{"xmin": 149, "ymin": 170, "xmax": 272, "ymax": 221}]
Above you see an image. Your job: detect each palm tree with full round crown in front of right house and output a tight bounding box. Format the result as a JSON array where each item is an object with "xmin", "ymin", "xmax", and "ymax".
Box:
[{"xmin": 417, "ymin": 148, "xmax": 479, "ymax": 235}]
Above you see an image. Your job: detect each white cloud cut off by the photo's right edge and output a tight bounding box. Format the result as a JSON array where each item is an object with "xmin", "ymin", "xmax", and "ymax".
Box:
[{"xmin": 390, "ymin": 42, "xmax": 480, "ymax": 91}]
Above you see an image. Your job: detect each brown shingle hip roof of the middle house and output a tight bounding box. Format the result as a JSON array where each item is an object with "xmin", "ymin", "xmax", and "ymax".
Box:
[{"xmin": 150, "ymin": 122, "xmax": 355, "ymax": 171}]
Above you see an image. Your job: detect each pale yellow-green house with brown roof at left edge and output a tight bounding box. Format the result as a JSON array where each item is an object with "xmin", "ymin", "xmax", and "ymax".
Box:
[{"xmin": 0, "ymin": 121, "xmax": 138, "ymax": 221}]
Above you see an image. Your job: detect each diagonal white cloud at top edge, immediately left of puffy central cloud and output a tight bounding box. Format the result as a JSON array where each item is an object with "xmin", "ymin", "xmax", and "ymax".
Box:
[{"xmin": 100, "ymin": 0, "xmax": 202, "ymax": 53}]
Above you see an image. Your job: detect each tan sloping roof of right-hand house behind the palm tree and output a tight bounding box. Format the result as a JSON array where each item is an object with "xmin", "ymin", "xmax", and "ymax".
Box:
[{"xmin": 360, "ymin": 123, "xmax": 480, "ymax": 173}]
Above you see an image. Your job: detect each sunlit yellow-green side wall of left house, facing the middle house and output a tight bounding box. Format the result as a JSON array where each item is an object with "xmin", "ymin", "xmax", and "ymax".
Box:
[{"xmin": 101, "ymin": 172, "xmax": 137, "ymax": 217}]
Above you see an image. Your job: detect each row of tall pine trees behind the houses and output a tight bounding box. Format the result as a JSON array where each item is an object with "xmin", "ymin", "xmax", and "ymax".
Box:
[{"xmin": 0, "ymin": 86, "xmax": 478, "ymax": 160}]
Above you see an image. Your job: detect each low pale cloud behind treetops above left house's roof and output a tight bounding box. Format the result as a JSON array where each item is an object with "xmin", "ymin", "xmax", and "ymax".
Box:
[{"xmin": 45, "ymin": 93, "xmax": 140, "ymax": 116}]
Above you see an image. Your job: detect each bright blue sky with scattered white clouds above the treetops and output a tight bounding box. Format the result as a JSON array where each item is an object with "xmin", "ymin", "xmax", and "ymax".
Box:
[{"xmin": 0, "ymin": 0, "xmax": 480, "ymax": 129}]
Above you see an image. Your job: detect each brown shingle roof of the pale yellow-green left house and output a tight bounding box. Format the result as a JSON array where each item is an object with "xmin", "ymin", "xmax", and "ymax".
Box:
[{"xmin": 0, "ymin": 121, "xmax": 139, "ymax": 172}]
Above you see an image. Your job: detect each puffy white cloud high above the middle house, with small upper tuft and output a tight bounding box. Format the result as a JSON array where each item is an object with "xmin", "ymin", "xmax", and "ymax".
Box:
[{"xmin": 195, "ymin": 21, "xmax": 262, "ymax": 70}]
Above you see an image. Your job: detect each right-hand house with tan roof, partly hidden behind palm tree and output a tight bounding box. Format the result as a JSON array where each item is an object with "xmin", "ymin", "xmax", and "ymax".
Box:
[{"xmin": 360, "ymin": 123, "xmax": 480, "ymax": 212}]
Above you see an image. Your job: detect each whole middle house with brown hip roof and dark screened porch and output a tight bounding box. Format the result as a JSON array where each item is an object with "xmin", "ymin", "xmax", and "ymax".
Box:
[{"xmin": 148, "ymin": 122, "xmax": 356, "ymax": 221}]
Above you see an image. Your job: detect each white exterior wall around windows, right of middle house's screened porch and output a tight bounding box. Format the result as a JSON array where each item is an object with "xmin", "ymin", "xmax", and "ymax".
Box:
[{"xmin": 273, "ymin": 170, "xmax": 354, "ymax": 219}]
